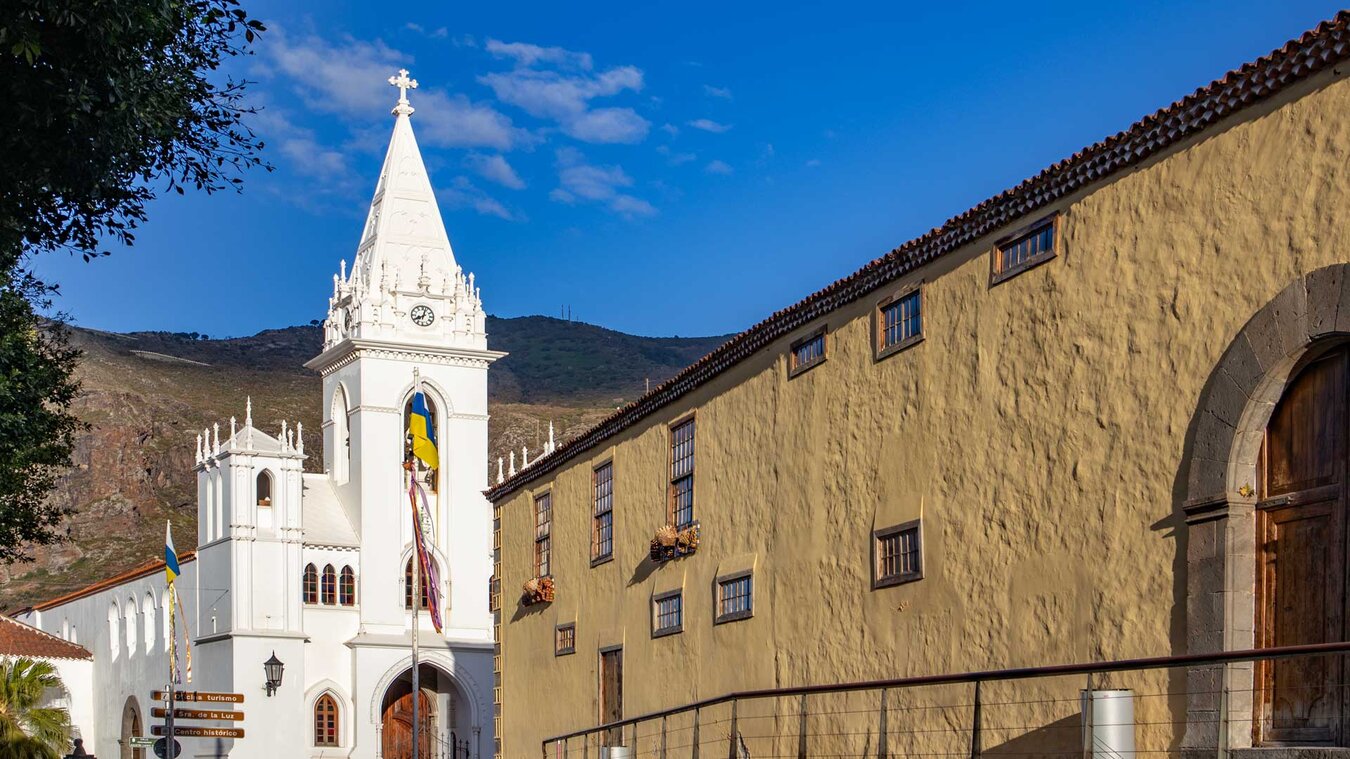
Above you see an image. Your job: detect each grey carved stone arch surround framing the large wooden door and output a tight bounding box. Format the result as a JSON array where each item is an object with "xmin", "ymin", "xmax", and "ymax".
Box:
[{"xmin": 1183, "ymin": 263, "xmax": 1350, "ymax": 755}]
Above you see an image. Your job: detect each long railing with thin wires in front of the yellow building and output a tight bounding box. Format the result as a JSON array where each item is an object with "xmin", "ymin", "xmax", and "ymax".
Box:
[{"xmin": 541, "ymin": 642, "xmax": 1350, "ymax": 759}]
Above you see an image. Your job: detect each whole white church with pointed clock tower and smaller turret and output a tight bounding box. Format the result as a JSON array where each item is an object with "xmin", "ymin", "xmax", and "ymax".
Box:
[{"xmin": 19, "ymin": 72, "xmax": 505, "ymax": 759}]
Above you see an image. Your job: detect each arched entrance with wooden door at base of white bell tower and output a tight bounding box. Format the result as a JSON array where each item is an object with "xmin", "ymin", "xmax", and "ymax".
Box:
[{"xmin": 379, "ymin": 664, "xmax": 470, "ymax": 759}]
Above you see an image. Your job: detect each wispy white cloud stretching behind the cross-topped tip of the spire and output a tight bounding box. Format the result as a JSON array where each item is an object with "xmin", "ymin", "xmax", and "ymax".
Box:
[{"xmin": 263, "ymin": 24, "xmax": 529, "ymax": 150}]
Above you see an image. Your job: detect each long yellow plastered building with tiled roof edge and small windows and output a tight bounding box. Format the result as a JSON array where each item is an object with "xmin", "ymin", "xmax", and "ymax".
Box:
[{"xmin": 489, "ymin": 12, "xmax": 1350, "ymax": 758}]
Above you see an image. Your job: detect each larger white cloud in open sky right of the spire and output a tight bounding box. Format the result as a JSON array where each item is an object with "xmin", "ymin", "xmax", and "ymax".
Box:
[{"xmin": 478, "ymin": 39, "xmax": 651, "ymax": 143}]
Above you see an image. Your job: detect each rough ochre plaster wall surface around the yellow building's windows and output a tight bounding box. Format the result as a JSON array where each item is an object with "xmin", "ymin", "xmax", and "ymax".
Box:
[{"xmin": 504, "ymin": 73, "xmax": 1350, "ymax": 751}]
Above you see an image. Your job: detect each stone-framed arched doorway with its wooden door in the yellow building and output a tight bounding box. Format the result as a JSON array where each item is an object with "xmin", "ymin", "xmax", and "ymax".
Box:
[{"xmin": 1177, "ymin": 263, "xmax": 1350, "ymax": 751}]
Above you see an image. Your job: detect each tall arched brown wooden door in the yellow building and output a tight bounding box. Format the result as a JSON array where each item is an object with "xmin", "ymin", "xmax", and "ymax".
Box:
[{"xmin": 1256, "ymin": 348, "xmax": 1350, "ymax": 745}]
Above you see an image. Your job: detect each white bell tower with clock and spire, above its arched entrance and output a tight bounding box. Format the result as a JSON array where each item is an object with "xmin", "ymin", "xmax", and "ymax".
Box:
[{"xmin": 305, "ymin": 70, "xmax": 505, "ymax": 642}]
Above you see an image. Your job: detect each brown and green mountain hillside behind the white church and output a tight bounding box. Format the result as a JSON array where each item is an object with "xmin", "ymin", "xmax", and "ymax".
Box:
[{"xmin": 0, "ymin": 316, "xmax": 724, "ymax": 608}]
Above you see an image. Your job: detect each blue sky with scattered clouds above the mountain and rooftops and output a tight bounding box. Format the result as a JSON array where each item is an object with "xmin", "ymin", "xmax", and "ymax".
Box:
[{"xmin": 36, "ymin": 0, "xmax": 1337, "ymax": 336}]
